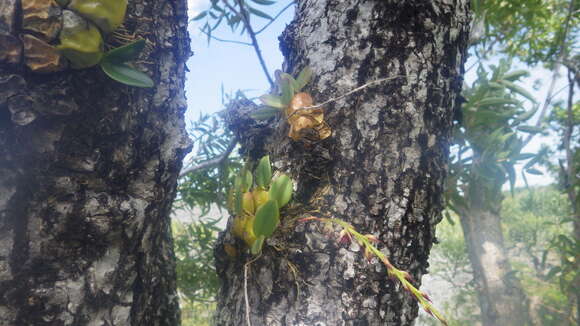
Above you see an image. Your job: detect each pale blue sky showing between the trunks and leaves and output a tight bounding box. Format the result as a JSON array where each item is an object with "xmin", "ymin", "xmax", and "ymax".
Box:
[{"xmin": 185, "ymin": 0, "xmax": 578, "ymax": 189}]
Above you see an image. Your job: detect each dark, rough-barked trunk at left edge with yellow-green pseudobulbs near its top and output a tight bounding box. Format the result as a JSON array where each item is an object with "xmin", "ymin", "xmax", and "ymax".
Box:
[{"xmin": 0, "ymin": 0, "xmax": 189, "ymax": 326}]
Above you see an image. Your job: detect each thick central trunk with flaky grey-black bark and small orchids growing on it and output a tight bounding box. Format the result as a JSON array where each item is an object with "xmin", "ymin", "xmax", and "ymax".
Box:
[{"xmin": 216, "ymin": 0, "xmax": 469, "ymax": 326}]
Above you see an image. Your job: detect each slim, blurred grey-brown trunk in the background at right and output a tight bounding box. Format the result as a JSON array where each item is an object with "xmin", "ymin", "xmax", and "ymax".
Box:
[{"xmin": 460, "ymin": 180, "xmax": 528, "ymax": 326}]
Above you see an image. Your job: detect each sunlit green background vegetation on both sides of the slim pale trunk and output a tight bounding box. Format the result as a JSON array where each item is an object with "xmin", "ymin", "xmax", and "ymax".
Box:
[{"xmin": 431, "ymin": 187, "xmax": 579, "ymax": 326}]
